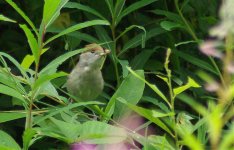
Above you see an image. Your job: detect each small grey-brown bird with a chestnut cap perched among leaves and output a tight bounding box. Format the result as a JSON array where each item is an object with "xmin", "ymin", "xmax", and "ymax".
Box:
[{"xmin": 66, "ymin": 43, "xmax": 110, "ymax": 101}]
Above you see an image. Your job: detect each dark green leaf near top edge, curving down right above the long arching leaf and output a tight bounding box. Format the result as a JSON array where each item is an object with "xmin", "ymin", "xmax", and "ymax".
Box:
[{"xmin": 65, "ymin": 2, "xmax": 106, "ymax": 20}]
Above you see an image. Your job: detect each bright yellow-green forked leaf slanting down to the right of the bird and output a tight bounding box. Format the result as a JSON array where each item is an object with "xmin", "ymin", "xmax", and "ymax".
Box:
[{"xmin": 117, "ymin": 97, "xmax": 174, "ymax": 136}]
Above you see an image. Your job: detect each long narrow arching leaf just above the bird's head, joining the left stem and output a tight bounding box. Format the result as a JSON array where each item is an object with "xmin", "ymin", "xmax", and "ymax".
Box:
[{"xmin": 45, "ymin": 20, "xmax": 109, "ymax": 45}]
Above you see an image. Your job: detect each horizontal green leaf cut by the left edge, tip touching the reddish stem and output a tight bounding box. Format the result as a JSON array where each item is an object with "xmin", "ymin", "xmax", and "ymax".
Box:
[{"xmin": 0, "ymin": 112, "xmax": 26, "ymax": 123}]
